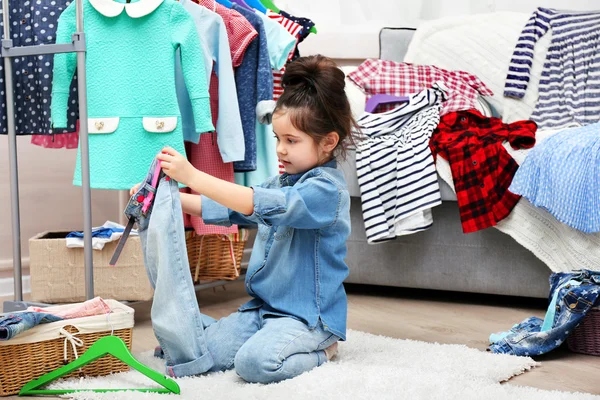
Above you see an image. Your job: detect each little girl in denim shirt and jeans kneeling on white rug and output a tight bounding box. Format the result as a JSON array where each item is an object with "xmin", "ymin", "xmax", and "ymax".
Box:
[{"xmin": 137, "ymin": 55, "xmax": 355, "ymax": 383}]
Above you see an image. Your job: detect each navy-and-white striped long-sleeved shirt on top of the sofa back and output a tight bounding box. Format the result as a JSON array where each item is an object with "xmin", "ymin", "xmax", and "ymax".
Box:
[{"xmin": 504, "ymin": 7, "xmax": 600, "ymax": 128}]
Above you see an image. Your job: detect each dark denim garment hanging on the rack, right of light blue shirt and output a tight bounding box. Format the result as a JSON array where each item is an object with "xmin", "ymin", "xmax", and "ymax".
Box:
[{"xmin": 232, "ymin": 3, "xmax": 273, "ymax": 172}]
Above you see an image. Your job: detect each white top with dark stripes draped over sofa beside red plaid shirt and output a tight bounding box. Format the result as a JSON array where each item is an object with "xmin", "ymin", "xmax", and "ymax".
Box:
[{"xmin": 356, "ymin": 83, "xmax": 446, "ymax": 243}]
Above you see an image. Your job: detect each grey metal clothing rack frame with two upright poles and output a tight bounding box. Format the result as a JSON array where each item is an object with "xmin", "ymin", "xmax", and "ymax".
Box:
[{"xmin": 2, "ymin": 0, "xmax": 94, "ymax": 312}]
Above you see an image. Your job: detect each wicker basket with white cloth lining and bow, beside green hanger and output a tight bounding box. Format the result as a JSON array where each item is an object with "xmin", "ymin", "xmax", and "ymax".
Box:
[{"xmin": 0, "ymin": 300, "xmax": 133, "ymax": 396}]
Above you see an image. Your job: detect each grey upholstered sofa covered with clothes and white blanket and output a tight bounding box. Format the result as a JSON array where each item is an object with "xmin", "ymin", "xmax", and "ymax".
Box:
[{"xmin": 341, "ymin": 28, "xmax": 551, "ymax": 298}]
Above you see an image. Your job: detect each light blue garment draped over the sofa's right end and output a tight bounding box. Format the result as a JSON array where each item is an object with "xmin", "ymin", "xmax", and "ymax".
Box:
[{"xmin": 508, "ymin": 123, "xmax": 600, "ymax": 233}]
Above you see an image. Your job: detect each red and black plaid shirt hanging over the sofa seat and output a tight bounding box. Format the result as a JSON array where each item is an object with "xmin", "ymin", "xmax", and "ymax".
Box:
[{"xmin": 429, "ymin": 110, "xmax": 537, "ymax": 233}]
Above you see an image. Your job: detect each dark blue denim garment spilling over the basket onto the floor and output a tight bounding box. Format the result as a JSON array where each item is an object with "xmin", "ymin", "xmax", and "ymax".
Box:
[{"xmin": 489, "ymin": 270, "xmax": 600, "ymax": 356}]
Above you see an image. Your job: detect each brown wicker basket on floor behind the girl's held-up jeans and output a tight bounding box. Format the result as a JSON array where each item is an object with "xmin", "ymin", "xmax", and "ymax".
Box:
[{"xmin": 185, "ymin": 229, "xmax": 248, "ymax": 283}]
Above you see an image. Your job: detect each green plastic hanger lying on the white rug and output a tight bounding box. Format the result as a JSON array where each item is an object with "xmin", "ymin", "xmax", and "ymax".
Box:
[{"xmin": 19, "ymin": 336, "xmax": 180, "ymax": 396}]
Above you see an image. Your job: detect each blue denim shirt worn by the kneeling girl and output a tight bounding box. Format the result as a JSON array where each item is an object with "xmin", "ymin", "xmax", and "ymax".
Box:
[{"xmin": 202, "ymin": 161, "xmax": 350, "ymax": 340}]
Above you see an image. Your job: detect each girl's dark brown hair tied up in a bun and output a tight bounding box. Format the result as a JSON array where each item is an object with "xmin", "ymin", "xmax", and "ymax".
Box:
[{"xmin": 273, "ymin": 54, "xmax": 358, "ymax": 156}]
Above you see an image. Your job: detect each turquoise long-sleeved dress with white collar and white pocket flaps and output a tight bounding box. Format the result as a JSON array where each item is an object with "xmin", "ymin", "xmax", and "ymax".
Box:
[{"xmin": 51, "ymin": 0, "xmax": 214, "ymax": 189}]
